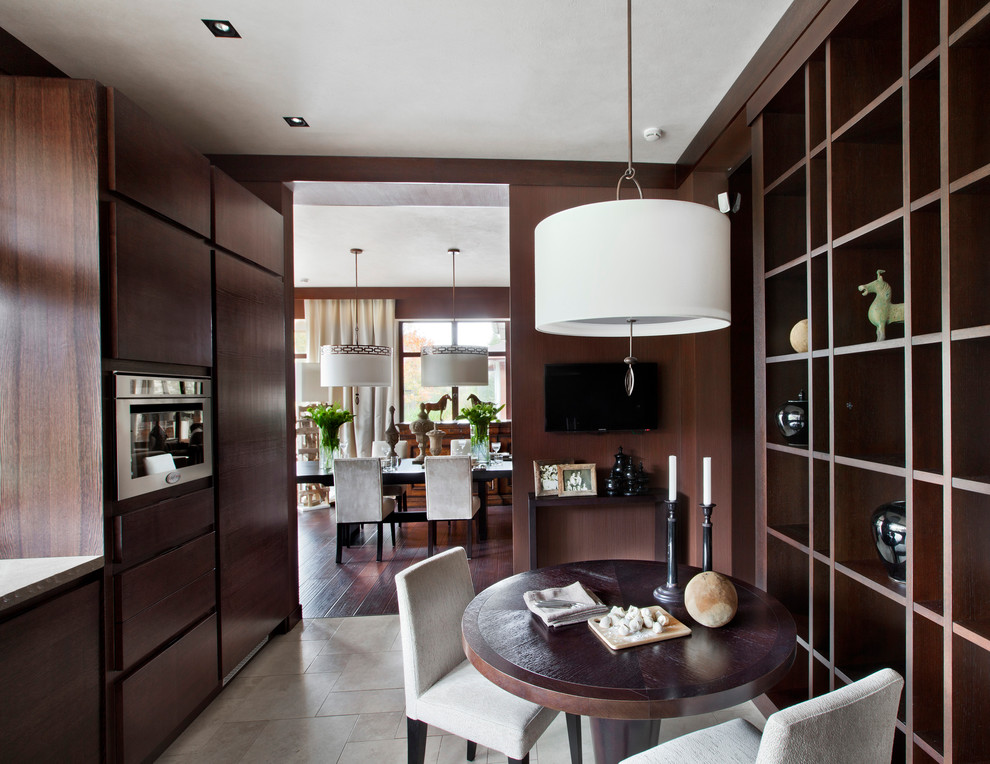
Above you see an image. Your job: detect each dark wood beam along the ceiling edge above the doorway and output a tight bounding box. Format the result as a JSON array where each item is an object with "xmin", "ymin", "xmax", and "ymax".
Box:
[{"xmin": 208, "ymin": 154, "xmax": 679, "ymax": 188}]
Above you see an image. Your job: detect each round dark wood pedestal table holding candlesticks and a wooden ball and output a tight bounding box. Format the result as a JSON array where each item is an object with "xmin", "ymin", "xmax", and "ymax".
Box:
[{"xmin": 461, "ymin": 560, "xmax": 797, "ymax": 764}]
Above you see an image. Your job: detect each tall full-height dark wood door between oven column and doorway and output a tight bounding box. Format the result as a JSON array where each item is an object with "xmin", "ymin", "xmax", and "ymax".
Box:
[{"xmin": 215, "ymin": 252, "xmax": 298, "ymax": 675}]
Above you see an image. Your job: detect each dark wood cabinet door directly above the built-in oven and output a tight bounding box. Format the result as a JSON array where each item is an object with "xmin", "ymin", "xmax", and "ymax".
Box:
[{"xmin": 109, "ymin": 202, "xmax": 213, "ymax": 366}]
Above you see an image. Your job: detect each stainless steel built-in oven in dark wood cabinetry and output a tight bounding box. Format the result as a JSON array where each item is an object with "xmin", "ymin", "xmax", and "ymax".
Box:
[{"xmin": 113, "ymin": 372, "xmax": 213, "ymax": 499}]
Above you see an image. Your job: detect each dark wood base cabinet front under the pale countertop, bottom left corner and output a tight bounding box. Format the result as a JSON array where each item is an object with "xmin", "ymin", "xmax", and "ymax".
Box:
[{"xmin": 0, "ymin": 581, "xmax": 102, "ymax": 762}]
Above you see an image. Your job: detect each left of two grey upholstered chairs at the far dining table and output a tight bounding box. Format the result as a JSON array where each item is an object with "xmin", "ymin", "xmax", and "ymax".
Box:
[{"xmin": 333, "ymin": 457, "xmax": 395, "ymax": 565}]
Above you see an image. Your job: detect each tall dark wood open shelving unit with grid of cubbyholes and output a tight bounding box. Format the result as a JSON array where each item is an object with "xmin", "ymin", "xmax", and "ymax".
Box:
[{"xmin": 749, "ymin": 0, "xmax": 990, "ymax": 762}]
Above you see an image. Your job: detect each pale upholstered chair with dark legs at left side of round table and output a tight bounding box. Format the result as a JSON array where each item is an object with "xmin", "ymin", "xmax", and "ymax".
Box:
[{"xmin": 395, "ymin": 548, "xmax": 557, "ymax": 764}]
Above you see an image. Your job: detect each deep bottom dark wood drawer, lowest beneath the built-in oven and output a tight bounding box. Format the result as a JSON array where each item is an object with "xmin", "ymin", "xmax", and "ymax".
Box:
[{"xmin": 117, "ymin": 615, "xmax": 220, "ymax": 762}]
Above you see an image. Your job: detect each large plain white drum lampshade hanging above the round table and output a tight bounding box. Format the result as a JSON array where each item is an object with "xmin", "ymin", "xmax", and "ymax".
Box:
[{"xmin": 536, "ymin": 199, "xmax": 730, "ymax": 337}]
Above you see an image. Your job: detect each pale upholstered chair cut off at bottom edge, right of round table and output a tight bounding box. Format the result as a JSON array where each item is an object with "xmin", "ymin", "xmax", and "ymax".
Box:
[{"xmin": 620, "ymin": 669, "xmax": 904, "ymax": 764}]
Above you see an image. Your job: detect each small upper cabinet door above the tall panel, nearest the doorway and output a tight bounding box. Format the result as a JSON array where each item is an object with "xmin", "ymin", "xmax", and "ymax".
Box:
[{"xmin": 213, "ymin": 167, "xmax": 285, "ymax": 276}]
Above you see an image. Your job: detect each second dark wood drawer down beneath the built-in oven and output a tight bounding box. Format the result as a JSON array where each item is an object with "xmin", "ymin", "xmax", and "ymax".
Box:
[{"xmin": 114, "ymin": 533, "xmax": 216, "ymax": 622}]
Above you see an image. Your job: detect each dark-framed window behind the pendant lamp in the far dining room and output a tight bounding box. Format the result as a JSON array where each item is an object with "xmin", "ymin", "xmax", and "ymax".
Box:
[{"xmin": 399, "ymin": 321, "xmax": 509, "ymax": 422}]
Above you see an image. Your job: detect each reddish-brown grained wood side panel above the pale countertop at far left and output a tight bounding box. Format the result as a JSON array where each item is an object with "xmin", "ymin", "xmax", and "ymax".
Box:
[{"xmin": 0, "ymin": 77, "xmax": 103, "ymax": 558}]
